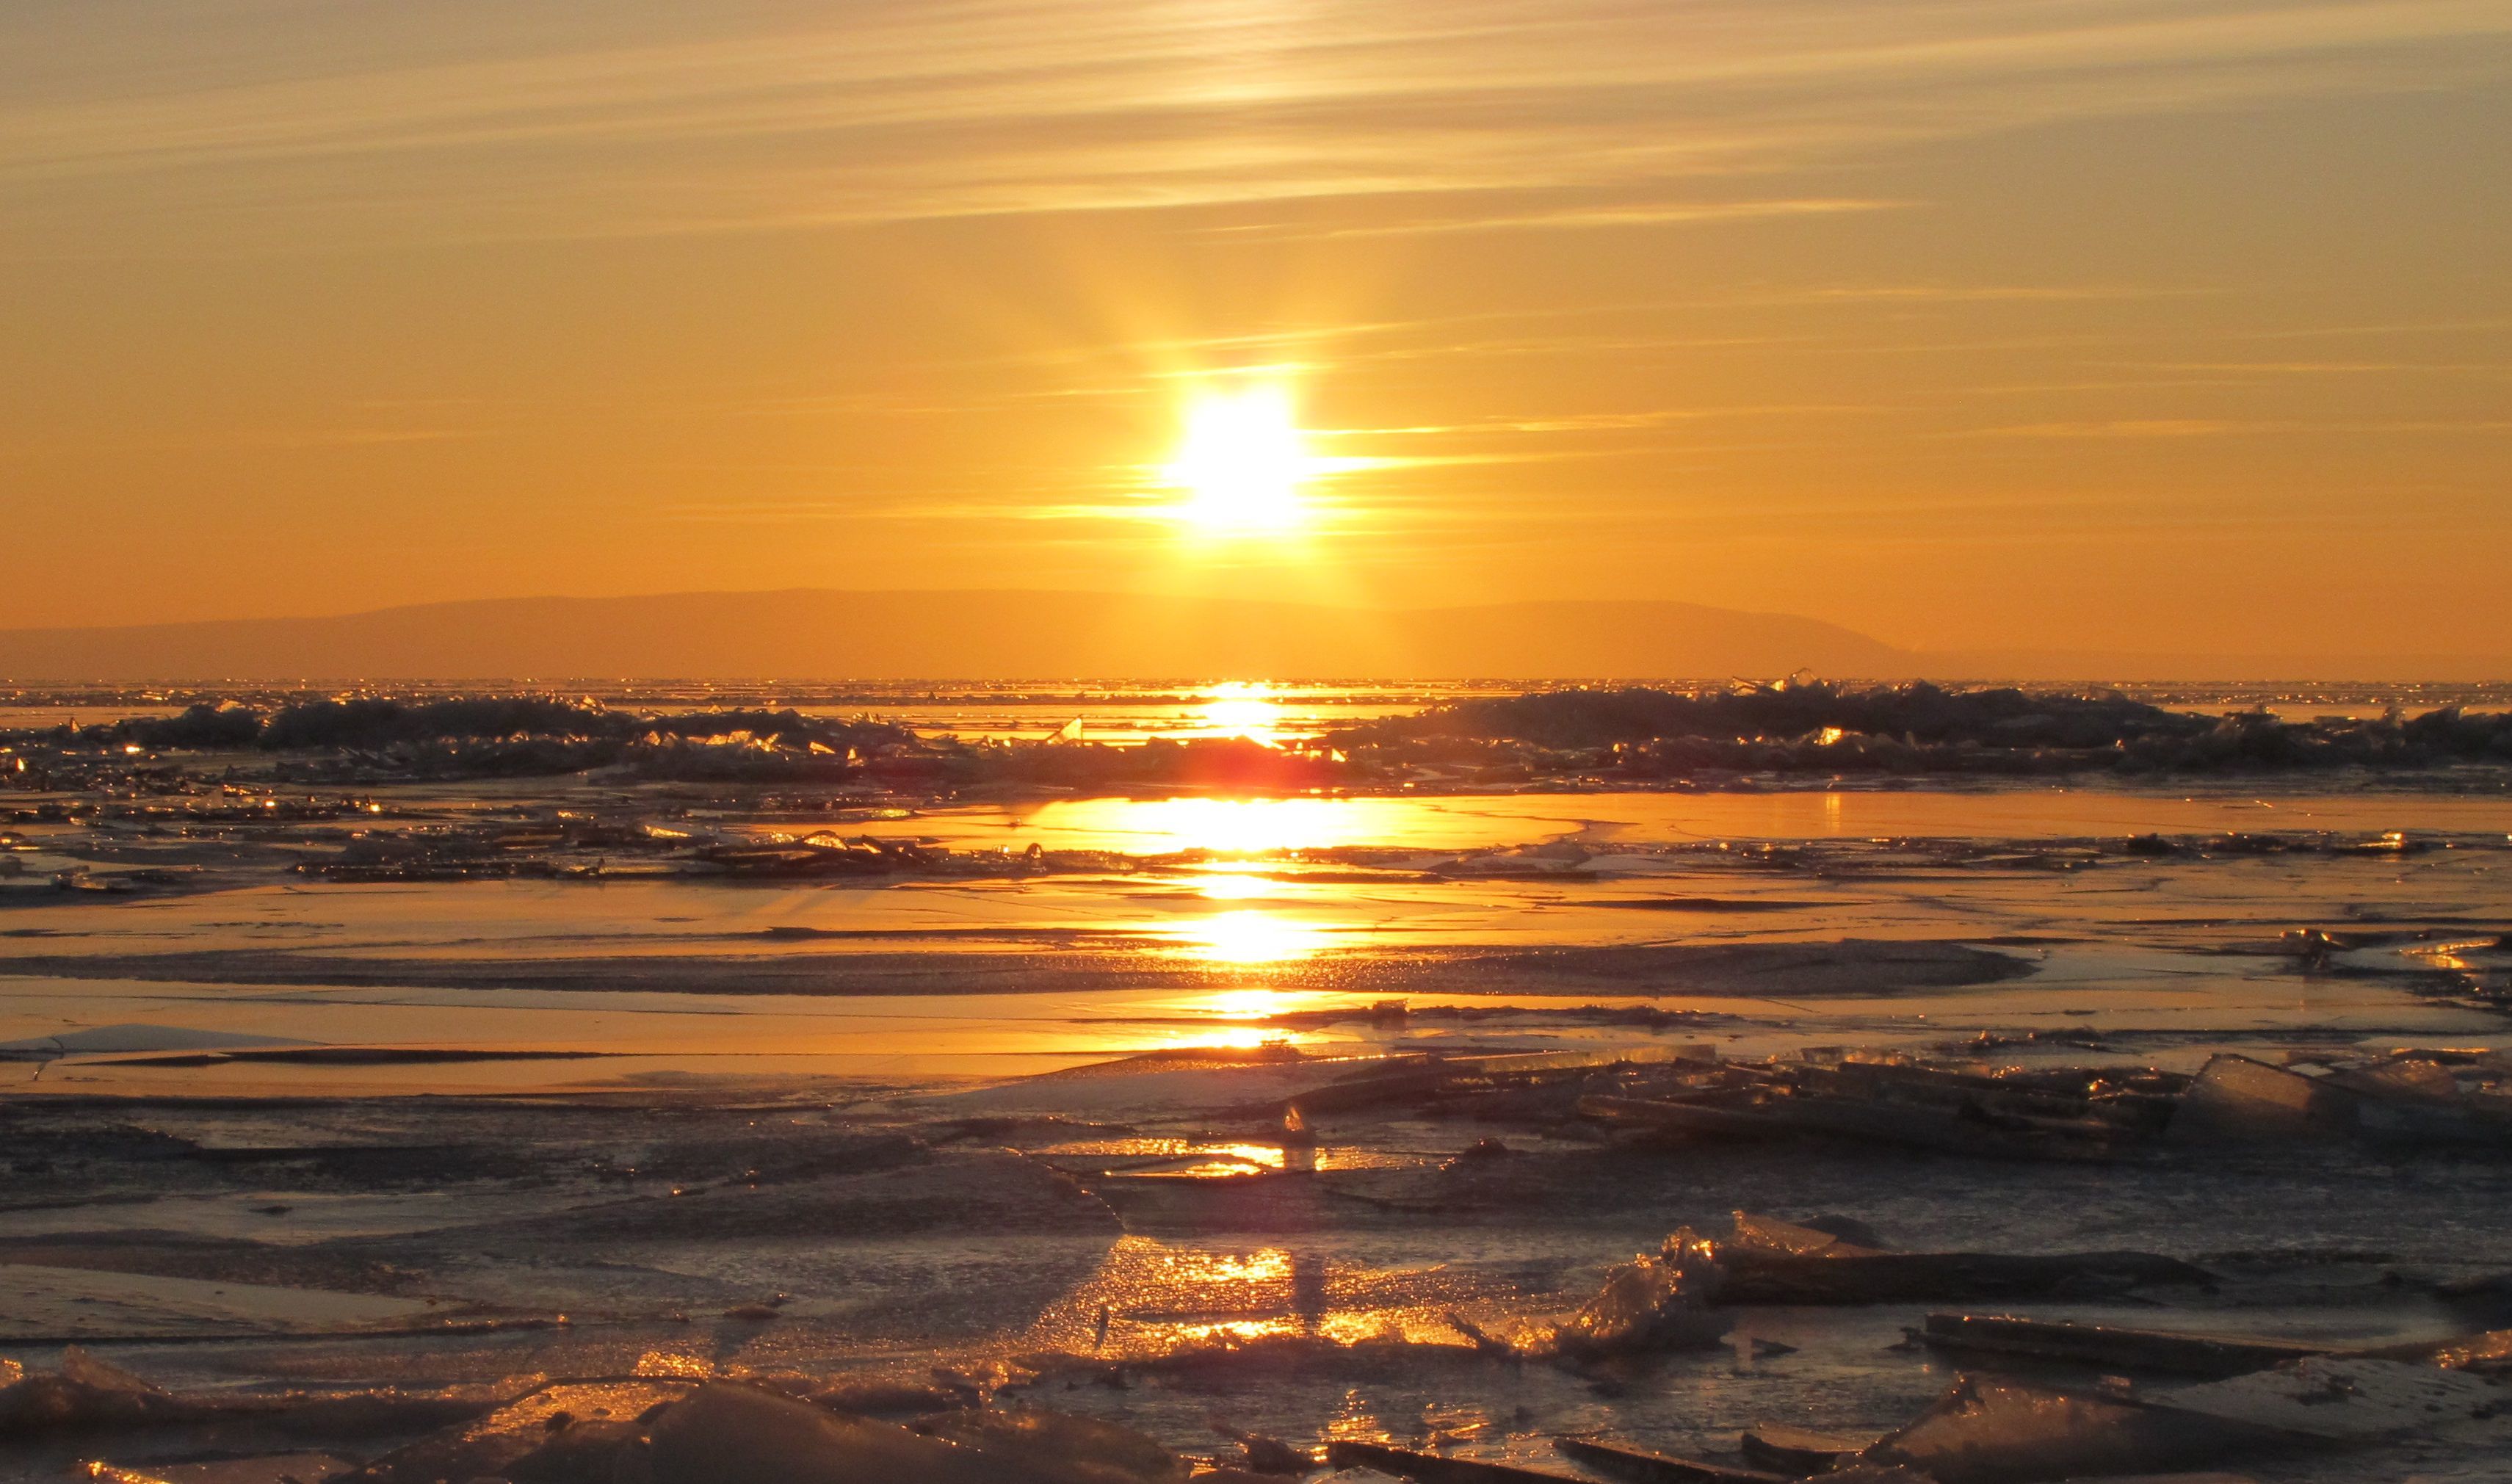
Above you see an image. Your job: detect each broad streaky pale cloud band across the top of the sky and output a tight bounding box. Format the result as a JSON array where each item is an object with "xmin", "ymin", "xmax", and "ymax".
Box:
[{"xmin": 0, "ymin": 0, "xmax": 2512, "ymax": 239}]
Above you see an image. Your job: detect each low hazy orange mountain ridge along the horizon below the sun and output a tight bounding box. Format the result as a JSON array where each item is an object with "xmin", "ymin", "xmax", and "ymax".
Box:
[{"xmin": 0, "ymin": 587, "xmax": 2512, "ymax": 686}]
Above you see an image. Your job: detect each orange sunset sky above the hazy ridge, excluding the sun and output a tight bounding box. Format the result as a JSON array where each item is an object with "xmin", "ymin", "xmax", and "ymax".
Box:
[{"xmin": 0, "ymin": 0, "xmax": 2512, "ymax": 653}]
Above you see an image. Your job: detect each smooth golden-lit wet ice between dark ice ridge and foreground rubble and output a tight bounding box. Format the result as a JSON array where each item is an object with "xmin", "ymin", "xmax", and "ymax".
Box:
[{"xmin": 0, "ymin": 789, "xmax": 2512, "ymax": 1090}]
